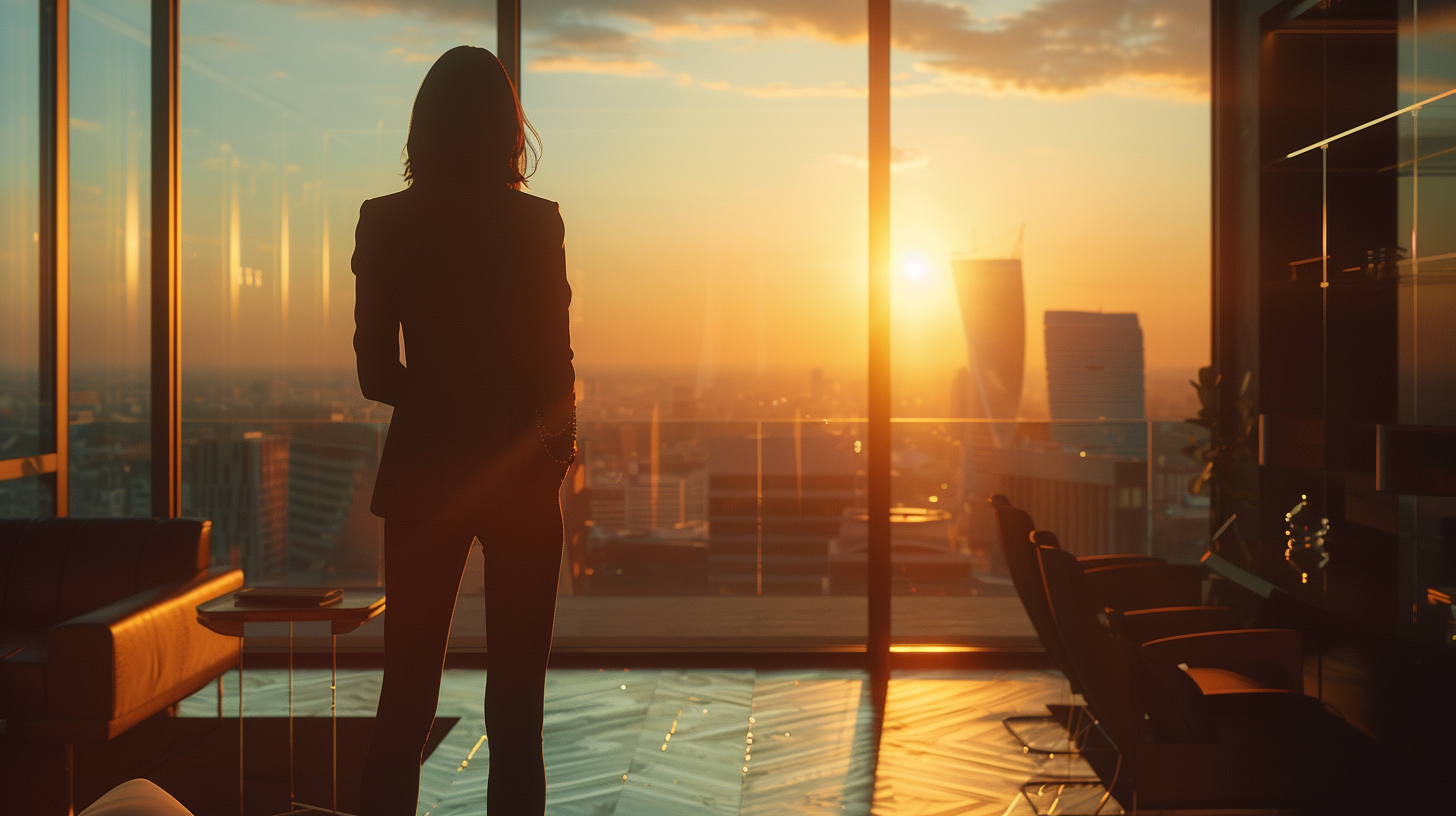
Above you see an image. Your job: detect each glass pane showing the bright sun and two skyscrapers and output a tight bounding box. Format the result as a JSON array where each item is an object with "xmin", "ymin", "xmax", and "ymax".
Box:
[{"xmin": 891, "ymin": 3, "xmax": 1210, "ymax": 644}]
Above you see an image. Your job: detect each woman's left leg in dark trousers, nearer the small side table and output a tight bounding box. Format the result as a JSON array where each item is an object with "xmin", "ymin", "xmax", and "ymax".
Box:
[{"xmin": 360, "ymin": 519, "xmax": 475, "ymax": 816}]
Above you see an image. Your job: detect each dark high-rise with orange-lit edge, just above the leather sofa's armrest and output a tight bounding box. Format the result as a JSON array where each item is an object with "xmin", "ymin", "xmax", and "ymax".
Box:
[{"xmin": 183, "ymin": 431, "xmax": 288, "ymax": 583}]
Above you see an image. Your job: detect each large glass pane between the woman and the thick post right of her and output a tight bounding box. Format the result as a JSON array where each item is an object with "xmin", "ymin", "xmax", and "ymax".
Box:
[{"xmin": 523, "ymin": 3, "xmax": 866, "ymax": 647}]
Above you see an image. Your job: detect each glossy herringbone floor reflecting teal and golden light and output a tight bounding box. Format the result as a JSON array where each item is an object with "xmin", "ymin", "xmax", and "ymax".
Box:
[{"xmin": 181, "ymin": 670, "xmax": 1120, "ymax": 816}]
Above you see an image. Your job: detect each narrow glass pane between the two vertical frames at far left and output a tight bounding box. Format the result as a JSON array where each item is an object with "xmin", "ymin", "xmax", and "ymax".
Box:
[{"xmin": 70, "ymin": 0, "xmax": 151, "ymax": 516}]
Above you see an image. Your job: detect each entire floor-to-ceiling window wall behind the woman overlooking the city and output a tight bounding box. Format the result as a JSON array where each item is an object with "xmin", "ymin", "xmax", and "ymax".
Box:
[{"xmin": 0, "ymin": 0, "xmax": 1208, "ymax": 646}]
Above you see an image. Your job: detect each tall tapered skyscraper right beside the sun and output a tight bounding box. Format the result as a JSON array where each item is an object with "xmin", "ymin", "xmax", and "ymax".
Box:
[{"xmin": 951, "ymin": 258, "xmax": 1026, "ymax": 420}]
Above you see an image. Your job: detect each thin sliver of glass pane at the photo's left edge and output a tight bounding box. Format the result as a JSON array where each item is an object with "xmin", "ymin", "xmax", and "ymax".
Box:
[{"xmin": 0, "ymin": 1, "xmax": 44, "ymax": 466}]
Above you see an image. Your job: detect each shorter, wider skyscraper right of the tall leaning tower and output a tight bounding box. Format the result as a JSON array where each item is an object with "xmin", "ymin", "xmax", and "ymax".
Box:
[{"xmin": 1045, "ymin": 312, "xmax": 1146, "ymax": 458}]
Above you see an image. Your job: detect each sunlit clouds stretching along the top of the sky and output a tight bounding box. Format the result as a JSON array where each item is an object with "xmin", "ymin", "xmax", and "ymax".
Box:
[{"xmin": 282, "ymin": 0, "xmax": 1208, "ymax": 99}]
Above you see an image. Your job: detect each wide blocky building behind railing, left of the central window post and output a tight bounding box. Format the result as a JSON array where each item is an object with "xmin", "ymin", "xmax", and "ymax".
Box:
[{"xmin": 708, "ymin": 431, "xmax": 862, "ymax": 595}]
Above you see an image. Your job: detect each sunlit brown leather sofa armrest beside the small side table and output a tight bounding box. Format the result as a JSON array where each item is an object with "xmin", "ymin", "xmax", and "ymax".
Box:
[{"xmin": 45, "ymin": 567, "xmax": 243, "ymax": 720}]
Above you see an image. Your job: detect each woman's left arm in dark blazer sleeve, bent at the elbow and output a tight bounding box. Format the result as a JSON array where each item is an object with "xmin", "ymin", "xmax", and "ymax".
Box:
[{"xmin": 354, "ymin": 201, "xmax": 405, "ymax": 405}]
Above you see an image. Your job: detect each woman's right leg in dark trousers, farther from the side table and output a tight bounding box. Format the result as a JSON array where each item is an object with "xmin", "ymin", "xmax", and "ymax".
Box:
[{"xmin": 478, "ymin": 460, "xmax": 562, "ymax": 816}]
